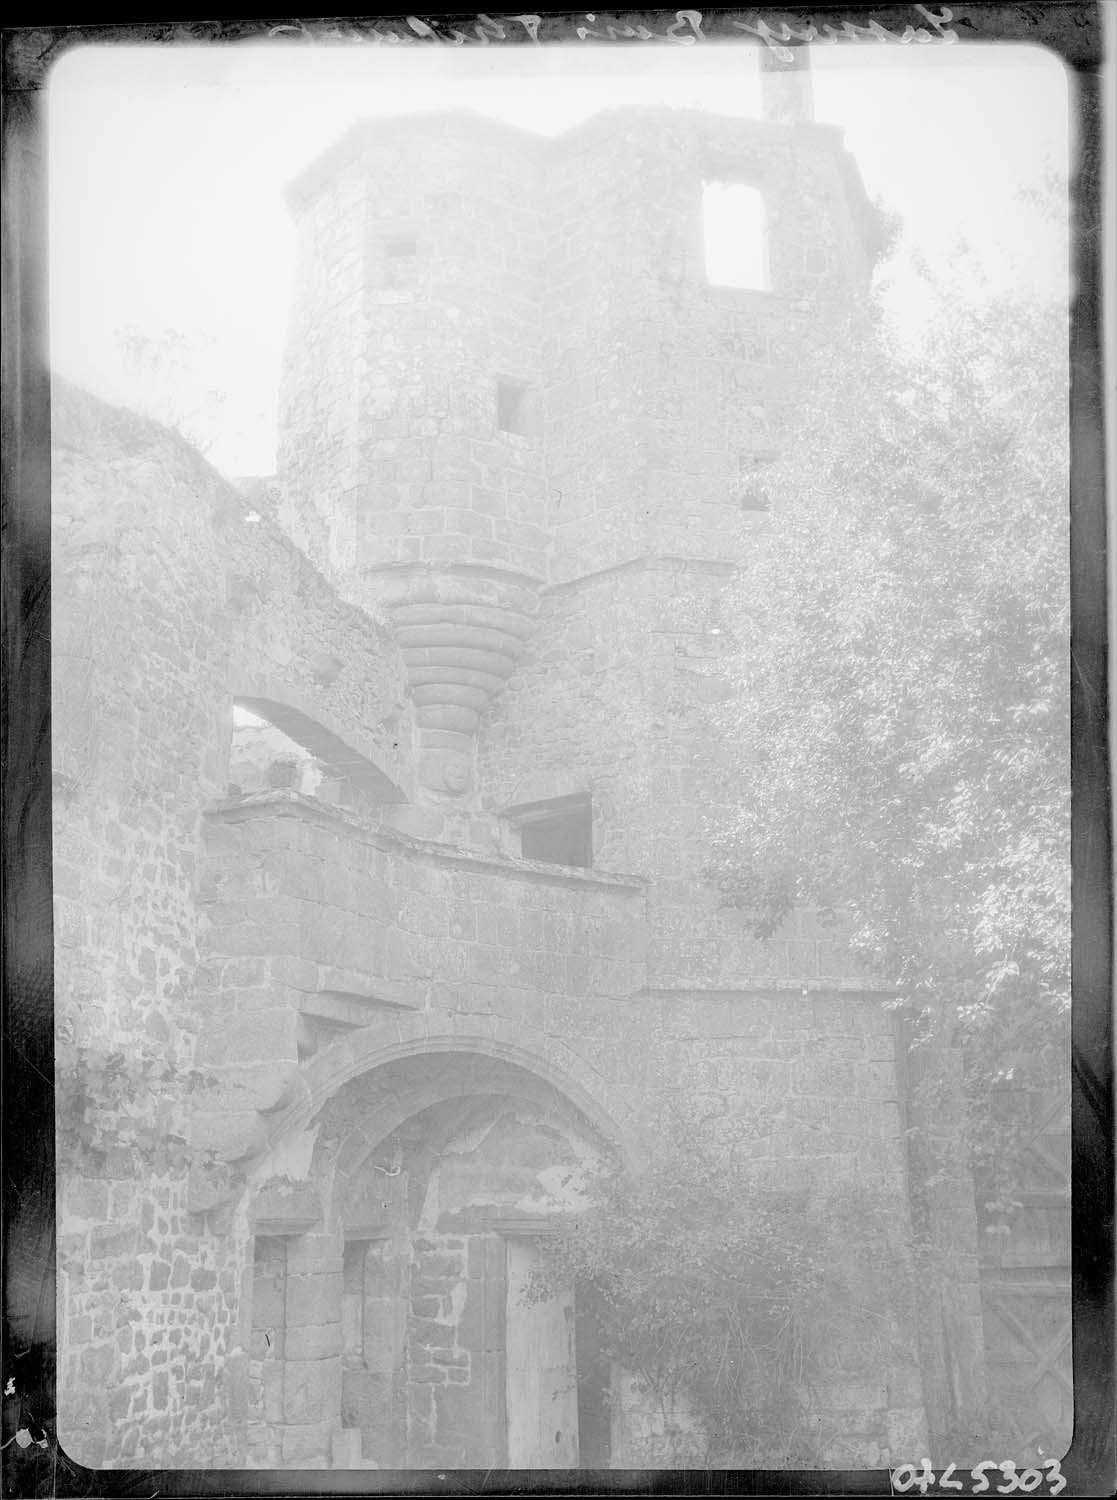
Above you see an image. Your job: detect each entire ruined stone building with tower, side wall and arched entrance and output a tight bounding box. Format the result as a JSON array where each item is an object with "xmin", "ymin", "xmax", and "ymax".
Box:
[{"xmin": 54, "ymin": 80, "xmax": 1069, "ymax": 1469}]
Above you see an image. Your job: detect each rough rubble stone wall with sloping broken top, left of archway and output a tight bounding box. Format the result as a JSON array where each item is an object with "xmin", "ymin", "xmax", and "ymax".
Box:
[{"xmin": 52, "ymin": 383, "xmax": 406, "ymax": 1467}]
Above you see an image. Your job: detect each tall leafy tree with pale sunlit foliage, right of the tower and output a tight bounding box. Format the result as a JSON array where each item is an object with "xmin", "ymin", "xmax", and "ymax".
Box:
[{"xmin": 711, "ymin": 283, "xmax": 1071, "ymax": 1202}]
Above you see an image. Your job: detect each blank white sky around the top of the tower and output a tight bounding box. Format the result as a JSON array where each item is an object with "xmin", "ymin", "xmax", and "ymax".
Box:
[{"xmin": 49, "ymin": 44, "xmax": 1069, "ymax": 476}]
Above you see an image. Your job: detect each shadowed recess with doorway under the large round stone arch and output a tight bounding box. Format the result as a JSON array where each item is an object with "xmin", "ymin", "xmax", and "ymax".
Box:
[{"xmin": 244, "ymin": 1052, "xmax": 623, "ymax": 1469}]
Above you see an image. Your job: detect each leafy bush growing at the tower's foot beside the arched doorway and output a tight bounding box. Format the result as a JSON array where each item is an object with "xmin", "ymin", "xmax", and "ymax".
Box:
[{"xmin": 529, "ymin": 1122, "xmax": 910, "ymax": 1469}]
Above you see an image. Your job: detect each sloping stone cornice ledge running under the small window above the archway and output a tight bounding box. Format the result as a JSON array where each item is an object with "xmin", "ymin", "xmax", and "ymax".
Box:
[{"xmin": 204, "ymin": 791, "xmax": 648, "ymax": 896}]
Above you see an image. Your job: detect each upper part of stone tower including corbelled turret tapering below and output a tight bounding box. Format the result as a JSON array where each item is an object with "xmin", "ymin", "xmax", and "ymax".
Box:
[{"xmin": 280, "ymin": 104, "xmax": 876, "ymax": 797}]
